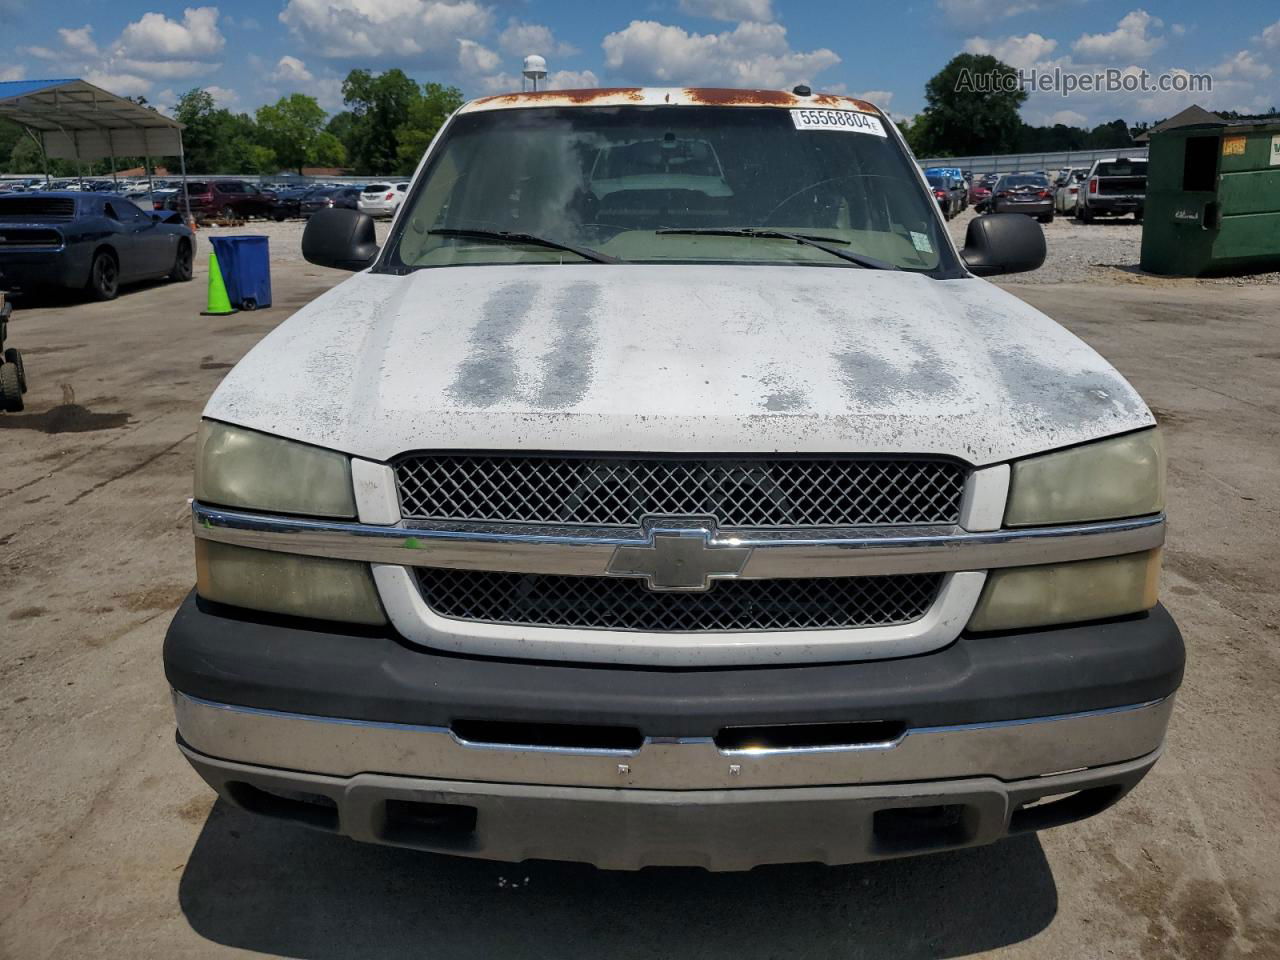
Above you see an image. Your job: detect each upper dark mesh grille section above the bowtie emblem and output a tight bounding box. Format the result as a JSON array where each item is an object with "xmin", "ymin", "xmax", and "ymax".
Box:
[{"xmin": 396, "ymin": 454, "xmax": 965, "ymax": 527}]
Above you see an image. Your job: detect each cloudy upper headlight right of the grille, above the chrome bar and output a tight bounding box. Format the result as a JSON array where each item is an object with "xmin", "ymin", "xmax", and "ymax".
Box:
[{"xmin": 1005, "ymin": 429, "xmax": 1165, "ymax": 526}]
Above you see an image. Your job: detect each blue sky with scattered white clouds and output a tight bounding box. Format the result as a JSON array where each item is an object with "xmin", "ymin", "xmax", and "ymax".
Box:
[{"xmin": 0, "ymin": 0, "xmax": 1280, "ymax": 127}]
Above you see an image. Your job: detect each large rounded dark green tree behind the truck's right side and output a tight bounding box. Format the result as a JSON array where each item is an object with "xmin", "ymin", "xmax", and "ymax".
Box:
[{"xmin": 916, "ymin": 54, "xmax": 1027, "ymax": 156}]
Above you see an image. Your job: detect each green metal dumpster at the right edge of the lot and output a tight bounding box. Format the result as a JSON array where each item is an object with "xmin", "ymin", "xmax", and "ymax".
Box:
[{"xmin": 1142, "ymin": 118, "xmax": 1280, "ymax": 276}]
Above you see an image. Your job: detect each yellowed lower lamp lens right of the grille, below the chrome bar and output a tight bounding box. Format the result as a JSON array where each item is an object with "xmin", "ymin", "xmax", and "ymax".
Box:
[{"xmin": 969, "ymin": 549, "xmax": 1160, "ymax": 631}]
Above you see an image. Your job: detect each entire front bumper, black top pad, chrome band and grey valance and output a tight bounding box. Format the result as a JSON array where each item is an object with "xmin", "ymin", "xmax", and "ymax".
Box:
[{"xmin": 165, "ymin": 595, "xmax": 1184, "ymax": 869}]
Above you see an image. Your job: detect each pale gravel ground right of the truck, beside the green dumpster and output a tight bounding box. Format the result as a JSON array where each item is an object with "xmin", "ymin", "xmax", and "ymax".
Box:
[{"xmin": 948, "ymin": 207, "xmax": 1280, "ymax": 287}]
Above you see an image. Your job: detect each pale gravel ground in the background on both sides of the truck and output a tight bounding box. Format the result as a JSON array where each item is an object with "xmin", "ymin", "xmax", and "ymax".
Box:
[{"xmin": 200, "ymin": 209, "xmax": 1280, "ymax": 287}]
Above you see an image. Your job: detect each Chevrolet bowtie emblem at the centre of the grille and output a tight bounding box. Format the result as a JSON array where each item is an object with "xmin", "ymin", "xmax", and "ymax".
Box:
[{"xmin": 608, "ymin": 520, "xmax": 751, "ymax": 591}]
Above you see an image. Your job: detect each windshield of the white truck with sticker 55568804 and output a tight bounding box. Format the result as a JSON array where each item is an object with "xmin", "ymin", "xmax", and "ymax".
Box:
[{"xmin": 378, "ymin": 106, "xmax": 964, "ymax": 276}]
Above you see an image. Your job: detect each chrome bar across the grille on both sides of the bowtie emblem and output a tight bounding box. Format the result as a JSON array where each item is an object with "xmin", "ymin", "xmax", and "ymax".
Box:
[{"xmin": 192, "ymin": 502, "xmax": 1165, "ymax": 580}]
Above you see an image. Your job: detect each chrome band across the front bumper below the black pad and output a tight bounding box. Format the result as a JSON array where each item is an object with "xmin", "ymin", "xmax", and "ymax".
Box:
[{"xmin": 173, "ymin": 691, "xmax": 1174, "ymax": 790}]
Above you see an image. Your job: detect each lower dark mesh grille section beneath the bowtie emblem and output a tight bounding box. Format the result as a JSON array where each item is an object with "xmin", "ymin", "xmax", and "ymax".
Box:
[{"xmin": 415, "ymin": 567, "xmax": 942, "ymax": 632}]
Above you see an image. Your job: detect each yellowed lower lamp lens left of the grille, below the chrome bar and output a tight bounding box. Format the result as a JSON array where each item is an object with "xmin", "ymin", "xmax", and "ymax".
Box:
[{"xmin": 196, "ymin": 540, "xmax": 387, "ymax": 625}]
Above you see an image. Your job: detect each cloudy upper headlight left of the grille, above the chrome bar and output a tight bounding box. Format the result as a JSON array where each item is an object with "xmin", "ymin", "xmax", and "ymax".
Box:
[{"xmin": 196, "ymin": 420, "xmax": 356, "ymax": 518}]
